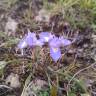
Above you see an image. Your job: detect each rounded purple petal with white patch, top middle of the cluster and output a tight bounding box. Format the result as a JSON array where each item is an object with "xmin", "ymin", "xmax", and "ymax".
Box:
[{"xmin": 39, "ymin": 32, "xmax": 54, "ymax": 42}]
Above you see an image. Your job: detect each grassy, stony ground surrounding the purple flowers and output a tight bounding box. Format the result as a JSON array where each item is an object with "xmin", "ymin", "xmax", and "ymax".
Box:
[{"xmin": 0, "ymin": 0, "xmax": 96, "ymax": 96}]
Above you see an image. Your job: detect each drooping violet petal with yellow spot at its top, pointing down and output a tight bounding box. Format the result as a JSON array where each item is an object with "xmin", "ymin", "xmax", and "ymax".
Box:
[{"xmin": 50, "ymin": 47, "xmax": 61, "ymax": 62}]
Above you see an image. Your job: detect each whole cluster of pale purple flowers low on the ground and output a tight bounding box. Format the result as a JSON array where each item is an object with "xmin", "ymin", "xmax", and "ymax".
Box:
[{"xmin": 18, "ymin": 32, "xmax": 72, "ymax": 62}]
